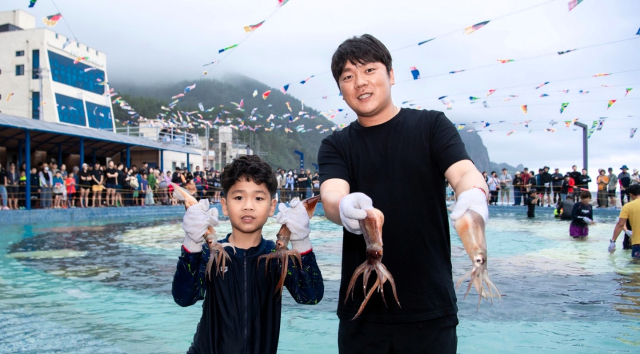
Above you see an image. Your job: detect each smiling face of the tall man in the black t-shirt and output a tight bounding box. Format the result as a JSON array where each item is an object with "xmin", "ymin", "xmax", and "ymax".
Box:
[{"xmin": 338, "ymin": 62, "xmax": 395, "ymax": 117}]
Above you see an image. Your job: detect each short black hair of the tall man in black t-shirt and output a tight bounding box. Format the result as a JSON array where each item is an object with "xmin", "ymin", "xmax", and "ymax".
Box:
[{"xmin": 331, "ymin": 34, "xmax": 392, "ymax": 86}]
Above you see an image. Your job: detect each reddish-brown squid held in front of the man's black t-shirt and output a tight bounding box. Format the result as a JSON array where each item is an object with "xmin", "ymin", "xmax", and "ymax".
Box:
[{"xmin": 344, "ymin": 208, "xmax": 402, "ymax": 321}]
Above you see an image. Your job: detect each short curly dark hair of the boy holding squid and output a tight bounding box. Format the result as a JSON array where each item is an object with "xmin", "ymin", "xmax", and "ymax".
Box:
[{"xmin": 220, "ymin": 155, "xmax": 278, "ymax": 198}]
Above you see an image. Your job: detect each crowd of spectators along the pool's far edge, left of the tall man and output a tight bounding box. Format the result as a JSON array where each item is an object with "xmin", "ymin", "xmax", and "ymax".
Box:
[{"xmin": 0, "ymin": 161, "xmax": 320, "ymax": 210}]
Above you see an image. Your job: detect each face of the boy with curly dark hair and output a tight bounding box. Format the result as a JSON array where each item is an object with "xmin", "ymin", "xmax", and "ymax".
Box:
[{"xmin": 221, "ymin": 178, "xmax": 276, "ymax": 237}]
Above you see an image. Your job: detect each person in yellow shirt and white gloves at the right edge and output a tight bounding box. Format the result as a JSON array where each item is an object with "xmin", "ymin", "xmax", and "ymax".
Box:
[{"xmin": 609, "ymin": 184, "xmax": 640, "ymax": 260}]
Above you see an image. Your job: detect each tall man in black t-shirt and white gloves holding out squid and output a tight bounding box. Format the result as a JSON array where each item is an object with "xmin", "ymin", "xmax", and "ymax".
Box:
[{"xmin": 318, "ymin": 35, "xmax": 489, "ymax": 354}]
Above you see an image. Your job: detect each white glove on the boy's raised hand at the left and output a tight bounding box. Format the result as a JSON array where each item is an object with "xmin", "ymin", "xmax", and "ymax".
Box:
[{"xmin": 182, "ymin": 199, "xmax": 220, "ymax": 252}]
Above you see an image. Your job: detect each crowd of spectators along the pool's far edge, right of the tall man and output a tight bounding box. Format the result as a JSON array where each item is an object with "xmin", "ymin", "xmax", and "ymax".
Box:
[{"xmin": 482, "ymin": 165, "xmax": 640, "ymax": 208}]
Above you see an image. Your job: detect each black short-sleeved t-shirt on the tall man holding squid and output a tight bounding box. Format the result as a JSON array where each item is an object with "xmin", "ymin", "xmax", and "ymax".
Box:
[{"xmin": 318, "ymin": 108, "xmax": 470, "ymax": 323}]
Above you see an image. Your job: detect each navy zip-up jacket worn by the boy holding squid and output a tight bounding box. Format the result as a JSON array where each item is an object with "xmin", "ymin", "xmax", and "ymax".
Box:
[{"xmin": 171, "ymin": 236, "xmax": 324, "ymax": 354}]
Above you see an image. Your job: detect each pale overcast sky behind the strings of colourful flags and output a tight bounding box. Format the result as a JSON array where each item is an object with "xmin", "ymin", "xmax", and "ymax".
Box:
[{"xmin": 0, "ymin": 0, "xmax": 640, "ymax": 181}]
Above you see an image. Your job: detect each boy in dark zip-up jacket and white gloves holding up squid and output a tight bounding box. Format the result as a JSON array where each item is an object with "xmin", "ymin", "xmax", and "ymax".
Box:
[{"xmin": 172, "ymin": 156, "xmax": 324, "ymax": 354}]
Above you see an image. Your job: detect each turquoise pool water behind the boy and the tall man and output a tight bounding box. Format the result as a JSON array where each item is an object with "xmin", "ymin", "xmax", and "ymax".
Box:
[{"xmin": 0, "ymin": 214, "xmax": 640, "ymax": 353}]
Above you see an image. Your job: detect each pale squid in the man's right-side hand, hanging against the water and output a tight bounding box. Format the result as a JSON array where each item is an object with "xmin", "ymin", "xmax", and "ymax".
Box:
[{"xmin": 454, "ymin": 210, "xmax": 501, "ymax": 309}]
